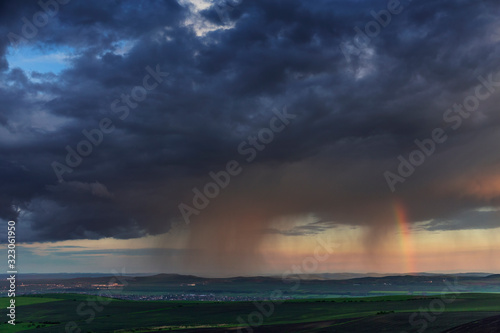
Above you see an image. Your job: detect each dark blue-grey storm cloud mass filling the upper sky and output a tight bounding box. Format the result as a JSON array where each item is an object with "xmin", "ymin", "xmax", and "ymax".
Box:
[{"xmin": 0, "ymin": 0, "xmax": 500, "ymax": 244}]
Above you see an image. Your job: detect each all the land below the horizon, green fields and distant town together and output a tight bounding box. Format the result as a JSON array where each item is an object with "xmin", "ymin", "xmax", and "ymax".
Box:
[{"xmin": 0, "ymin": 273, "xmax": 500, "ymax": 333}]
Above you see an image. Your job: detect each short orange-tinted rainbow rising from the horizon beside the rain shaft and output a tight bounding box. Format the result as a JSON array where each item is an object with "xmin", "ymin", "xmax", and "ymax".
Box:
[{"xmin": 394, "ymin": 201, "xmax": 417, "ymax": 273}]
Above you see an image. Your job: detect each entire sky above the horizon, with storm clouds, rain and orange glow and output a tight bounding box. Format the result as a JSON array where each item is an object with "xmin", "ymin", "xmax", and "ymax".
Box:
[{"xmin": 0, "ymin": 0, "xmax": 500, "ymax": 276}]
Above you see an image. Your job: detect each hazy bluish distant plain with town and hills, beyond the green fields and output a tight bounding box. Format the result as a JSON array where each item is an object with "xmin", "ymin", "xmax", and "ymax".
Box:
[{"xmin": 0, "ymin": 273, "xmax": 500, "ymax": 301}]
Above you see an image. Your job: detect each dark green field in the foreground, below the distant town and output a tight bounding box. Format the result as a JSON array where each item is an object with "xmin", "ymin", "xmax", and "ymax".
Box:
[{"xmin": 0, "ymin": 294, "xmax": 500, "ymax": 333}]
